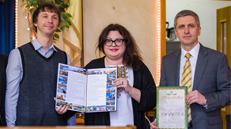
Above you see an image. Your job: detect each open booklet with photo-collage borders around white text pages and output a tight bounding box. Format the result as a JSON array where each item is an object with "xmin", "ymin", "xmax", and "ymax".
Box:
[{"xmin": 55, "ymin": 63, "xmax": 117, "ymax": 113}]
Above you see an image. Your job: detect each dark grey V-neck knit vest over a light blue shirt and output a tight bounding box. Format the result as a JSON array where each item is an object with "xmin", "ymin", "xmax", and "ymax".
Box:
[{"xmin": 16, "ymin": 43, "xmax": 67, "ymax": 126}]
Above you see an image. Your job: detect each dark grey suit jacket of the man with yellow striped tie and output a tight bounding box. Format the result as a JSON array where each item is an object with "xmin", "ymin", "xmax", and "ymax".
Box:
[{"xmin": 160, "ymin": 44, "xmax": 231, "ymax": 129}]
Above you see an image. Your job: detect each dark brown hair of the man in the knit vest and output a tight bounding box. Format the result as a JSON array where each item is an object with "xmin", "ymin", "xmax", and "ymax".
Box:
[{"xmin": 32, "ymin": 2, "xmax": 61, "ymax": 32}]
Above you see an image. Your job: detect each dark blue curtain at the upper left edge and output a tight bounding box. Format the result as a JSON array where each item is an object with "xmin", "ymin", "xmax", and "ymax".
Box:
[{"xmin": 0, "ymin": 0, "xmax": 15, "ymax": 55}]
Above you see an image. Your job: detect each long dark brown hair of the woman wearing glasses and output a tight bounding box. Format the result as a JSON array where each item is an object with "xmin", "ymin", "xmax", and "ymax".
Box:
[{"xmin": 96, "ymin": 24, "xmax": 142, "ymax": 71}]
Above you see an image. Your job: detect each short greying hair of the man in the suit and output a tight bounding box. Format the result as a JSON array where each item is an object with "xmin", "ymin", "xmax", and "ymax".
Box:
[{"xmin": 174, "ymin": 10, "xmax": 200, "ymax": 29}]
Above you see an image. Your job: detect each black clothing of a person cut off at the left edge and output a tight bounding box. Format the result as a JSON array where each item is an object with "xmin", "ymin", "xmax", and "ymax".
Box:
[{"xmin": 0, "ymin": 54, "xmax": 7, "ymax": 126}]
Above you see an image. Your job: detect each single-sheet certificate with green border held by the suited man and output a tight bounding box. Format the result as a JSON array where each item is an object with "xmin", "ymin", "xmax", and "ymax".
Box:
[{"xmin": 156, "ymin": 86, "xmax": 188, "ymax": 129}]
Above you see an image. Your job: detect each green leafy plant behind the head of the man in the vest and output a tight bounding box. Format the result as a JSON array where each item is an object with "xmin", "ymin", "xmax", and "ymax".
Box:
[{"xmin": 22, "ymin": 0, "xmax": 72, "ymax": 40}]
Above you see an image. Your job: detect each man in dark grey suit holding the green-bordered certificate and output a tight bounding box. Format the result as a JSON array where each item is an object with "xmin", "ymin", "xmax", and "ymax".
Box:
[{"xmin": 151, "ymin": 10, "xmax": 231, "ymax": 129}]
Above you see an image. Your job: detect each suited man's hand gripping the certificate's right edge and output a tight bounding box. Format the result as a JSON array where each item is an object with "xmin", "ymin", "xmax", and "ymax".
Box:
[{"xmin": 186, "ymin": 90, "xmax": 206, "ymax": 105}]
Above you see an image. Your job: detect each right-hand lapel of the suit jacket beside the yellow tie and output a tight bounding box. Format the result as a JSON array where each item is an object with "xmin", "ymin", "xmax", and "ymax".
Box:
[{"xmin": 193, "ymin": 44, "xmax": 208, "ymax": 90}]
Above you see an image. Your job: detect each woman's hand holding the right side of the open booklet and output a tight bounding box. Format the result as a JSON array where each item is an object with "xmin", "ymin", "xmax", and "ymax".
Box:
[{"xmin": 114, "ymin": 78, "xmax": 132, "ymax": 94}]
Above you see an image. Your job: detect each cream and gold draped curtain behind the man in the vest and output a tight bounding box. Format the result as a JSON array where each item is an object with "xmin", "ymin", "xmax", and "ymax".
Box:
[{"xmin": 63, "ymin": 0, "xmax": 83, "ymax": 67}]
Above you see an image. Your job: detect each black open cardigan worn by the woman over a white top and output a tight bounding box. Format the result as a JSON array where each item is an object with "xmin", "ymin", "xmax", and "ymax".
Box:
[{"xmin": 85, "ymin": 57, "xmax": 156, "ymax": 129}]
